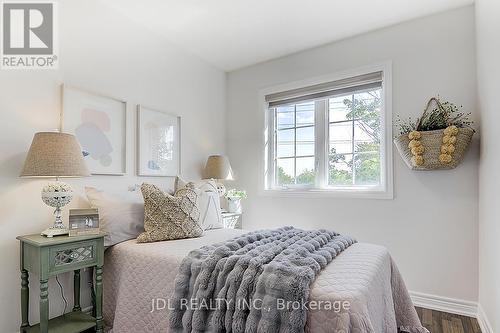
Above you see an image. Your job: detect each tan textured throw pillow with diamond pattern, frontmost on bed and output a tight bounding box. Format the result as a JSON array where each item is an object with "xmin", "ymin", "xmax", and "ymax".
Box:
[{"xmin": 137, "ymin": 184, "xmax": 203, "ymax": 243}]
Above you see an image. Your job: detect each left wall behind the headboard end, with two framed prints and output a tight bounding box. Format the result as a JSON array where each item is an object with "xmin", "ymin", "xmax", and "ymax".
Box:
[{"xmin": 0, "ymin": 0, "xmax": 226, "ymax": 332}]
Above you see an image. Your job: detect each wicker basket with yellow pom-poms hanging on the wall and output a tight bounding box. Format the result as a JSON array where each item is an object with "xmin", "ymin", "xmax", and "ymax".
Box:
[{"xmin": 394, "ymin": 97, "xmax": 474, "ymax": 170}]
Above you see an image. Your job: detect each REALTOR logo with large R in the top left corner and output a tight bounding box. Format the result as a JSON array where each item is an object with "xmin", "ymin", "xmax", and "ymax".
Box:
[{"xmin": 1, "ymin": 1, "xmax": 58, "ymax": 69}]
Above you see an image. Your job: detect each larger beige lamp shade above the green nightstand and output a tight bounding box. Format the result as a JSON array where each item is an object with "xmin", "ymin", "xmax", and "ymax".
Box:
[{"xmin": 21, "ymin": 132, "xmax": 90, "ymax": 177}]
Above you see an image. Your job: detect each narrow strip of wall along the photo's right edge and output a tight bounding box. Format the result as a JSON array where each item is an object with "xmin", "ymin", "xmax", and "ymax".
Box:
[{"xmin": 476, "ymin": 0, "xmax": 500, "ymax": 332}]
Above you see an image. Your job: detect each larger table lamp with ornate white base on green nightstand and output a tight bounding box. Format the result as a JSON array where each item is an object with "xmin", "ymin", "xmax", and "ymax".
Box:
[{"xmin": 20, "ymin": 132, "xmax": 90, "ymax": 237}]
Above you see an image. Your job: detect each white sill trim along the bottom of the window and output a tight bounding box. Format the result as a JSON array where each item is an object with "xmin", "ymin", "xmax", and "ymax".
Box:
[{"xmin": 260, "ymin": 188, "xmax": 394, "ymax": 200}]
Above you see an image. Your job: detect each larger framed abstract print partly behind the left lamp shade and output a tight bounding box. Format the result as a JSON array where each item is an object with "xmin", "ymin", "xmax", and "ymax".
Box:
[{"xmin": 61, "ymin": 86, "xmax": 127, "ymax": 175}]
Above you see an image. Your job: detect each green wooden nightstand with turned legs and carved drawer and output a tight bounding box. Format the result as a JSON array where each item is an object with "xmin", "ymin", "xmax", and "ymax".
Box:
[{"xmin": 17, "ymin": 233, "xmax": 104, "ymax": 333}]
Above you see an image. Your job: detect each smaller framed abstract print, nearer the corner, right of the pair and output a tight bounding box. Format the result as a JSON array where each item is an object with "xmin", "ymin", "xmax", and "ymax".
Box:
[{"xmin": 137, "ymin": 105, "xmax": 180, "ymax": 176}]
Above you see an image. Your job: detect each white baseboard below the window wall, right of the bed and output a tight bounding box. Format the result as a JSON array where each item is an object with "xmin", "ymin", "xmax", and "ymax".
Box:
[{"xmin": 410, "ymin": 291, "xmax": 478, "ymax": 318}]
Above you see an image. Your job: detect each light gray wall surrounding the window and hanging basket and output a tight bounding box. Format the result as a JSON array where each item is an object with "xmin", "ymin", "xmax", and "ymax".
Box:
[{"xmin": 227, "ymin": 6, "xmax": 478, "ymax": 301}]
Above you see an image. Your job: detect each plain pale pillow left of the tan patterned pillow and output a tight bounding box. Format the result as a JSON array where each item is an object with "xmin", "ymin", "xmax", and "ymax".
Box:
[{"xmin": 85, "ymin": 187, "xmax": 144, "ymax": 246}]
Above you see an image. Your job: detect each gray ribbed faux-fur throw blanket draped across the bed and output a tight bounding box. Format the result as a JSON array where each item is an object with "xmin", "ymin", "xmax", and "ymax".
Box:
[{"xmin": 169, "ymin": 227, "xmax": 356, "ymax": 333}]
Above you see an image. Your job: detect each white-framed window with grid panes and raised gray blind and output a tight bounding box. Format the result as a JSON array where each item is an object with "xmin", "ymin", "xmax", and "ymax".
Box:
[{"xmin": 265, "ymin": 70, "xmax": 392, "ymax": 197}]
